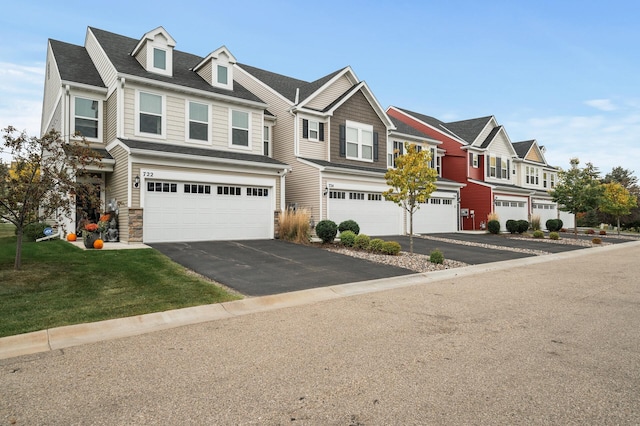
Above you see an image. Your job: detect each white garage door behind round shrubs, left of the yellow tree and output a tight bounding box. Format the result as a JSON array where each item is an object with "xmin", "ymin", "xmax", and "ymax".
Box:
[{"xmin": 327, "ymin": 190, "xmax": 402, "ymax": 235}]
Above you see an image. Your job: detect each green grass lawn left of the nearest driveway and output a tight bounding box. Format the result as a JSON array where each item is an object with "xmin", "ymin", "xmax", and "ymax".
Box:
[{"xmin": 0, "ymin": 224, "xmax": 240, "ymax": 337}]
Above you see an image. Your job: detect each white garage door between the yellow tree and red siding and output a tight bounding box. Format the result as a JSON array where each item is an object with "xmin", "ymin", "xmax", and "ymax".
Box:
[{"xmin": 407, "ymin": 195, "xmax": 458, "ymax": 234}]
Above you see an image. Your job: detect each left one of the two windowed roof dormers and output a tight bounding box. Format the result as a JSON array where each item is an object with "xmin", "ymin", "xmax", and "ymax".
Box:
[{"xmin": 131, "ymin": 27, "xmax": 176, "ymax": 77}]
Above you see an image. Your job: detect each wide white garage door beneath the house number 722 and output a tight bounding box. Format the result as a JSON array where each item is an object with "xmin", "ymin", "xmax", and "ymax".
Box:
[{"xmin": 143, "ymin": 181, "xmax": 274, "ymax": 243}]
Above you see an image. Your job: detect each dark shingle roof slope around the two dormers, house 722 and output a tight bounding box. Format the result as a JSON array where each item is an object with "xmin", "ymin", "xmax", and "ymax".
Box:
[{"xmin": 90, "ymin": 27, "xmax": 264, "ymax": 103}]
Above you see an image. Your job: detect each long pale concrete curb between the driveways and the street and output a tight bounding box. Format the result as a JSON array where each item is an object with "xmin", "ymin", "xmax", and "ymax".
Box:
[{"xmin": 0, "ymin": 241, "xmax": 640, "ymax": 360}]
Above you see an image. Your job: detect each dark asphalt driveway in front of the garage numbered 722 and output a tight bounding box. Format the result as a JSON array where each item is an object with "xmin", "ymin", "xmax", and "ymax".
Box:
[{"xmin": 151, "ymin": 240, "xmax": 415, "ymax": 296}]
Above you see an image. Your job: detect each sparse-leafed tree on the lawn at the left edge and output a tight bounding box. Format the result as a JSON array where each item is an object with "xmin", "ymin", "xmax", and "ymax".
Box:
[{"xmin": 0, "ymin": 126, "xmax": 100, "ymax": 270}]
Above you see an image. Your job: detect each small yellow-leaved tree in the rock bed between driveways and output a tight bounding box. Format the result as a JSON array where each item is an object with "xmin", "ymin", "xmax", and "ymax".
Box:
[{"xmin": 382, "ymin": 142, "xmax": 438, "ymax": 253}]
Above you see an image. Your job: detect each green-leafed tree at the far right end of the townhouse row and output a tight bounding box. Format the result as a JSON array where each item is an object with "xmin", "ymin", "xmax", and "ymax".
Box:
[{"xmin": 549, "ymin": 158, "xmax": 602, "ymax": 238}]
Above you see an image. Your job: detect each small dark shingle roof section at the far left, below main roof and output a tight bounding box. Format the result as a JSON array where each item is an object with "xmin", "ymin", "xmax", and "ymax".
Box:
[{"xmin": 49, "ymin": 40, "xmax": 105, "ymax": 87}]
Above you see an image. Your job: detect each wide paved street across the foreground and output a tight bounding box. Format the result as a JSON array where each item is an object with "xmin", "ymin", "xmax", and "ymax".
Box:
[{"xmin": 0, "ymin": 243, "xmax": 640, "ymax": 425}]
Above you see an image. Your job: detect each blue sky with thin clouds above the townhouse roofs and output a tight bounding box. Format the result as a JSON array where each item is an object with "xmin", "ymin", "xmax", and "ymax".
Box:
[{"xmin": 0, "ymin": 0, "xmax": 640, "ymax": 175}]
